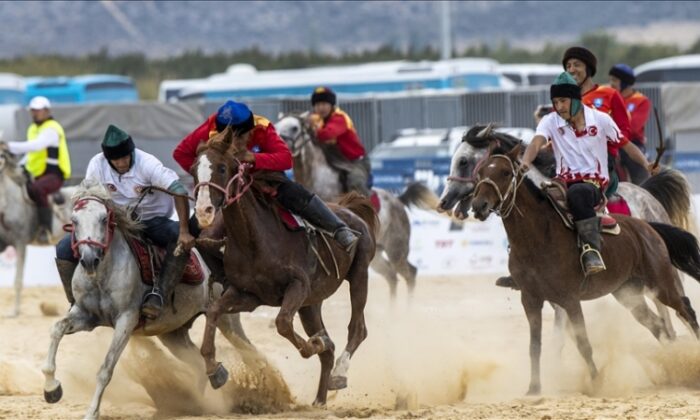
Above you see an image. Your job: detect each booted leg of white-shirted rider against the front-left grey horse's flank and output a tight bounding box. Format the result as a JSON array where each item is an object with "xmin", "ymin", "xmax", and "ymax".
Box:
[{"xmin": 141, "ymin": 216, "xmax": 190, "ymax": 319}]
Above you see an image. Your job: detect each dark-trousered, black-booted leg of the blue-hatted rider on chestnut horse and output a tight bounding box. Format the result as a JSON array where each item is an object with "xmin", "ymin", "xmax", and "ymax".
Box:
[{"xmin": 277, "ymin": 180, "xmax": 358, "ymax": 253}]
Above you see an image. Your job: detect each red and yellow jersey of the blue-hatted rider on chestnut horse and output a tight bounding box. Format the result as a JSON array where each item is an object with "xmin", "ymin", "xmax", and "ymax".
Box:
[{"xmin": 173, "ymin": 113, "xmax": 292, "ymax": 172}]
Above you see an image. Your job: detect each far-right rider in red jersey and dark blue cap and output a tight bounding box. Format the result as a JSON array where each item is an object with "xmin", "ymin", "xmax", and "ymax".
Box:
[{"xmin": 608, "ymin": 64, "xmax": 651, "ymax": 185}]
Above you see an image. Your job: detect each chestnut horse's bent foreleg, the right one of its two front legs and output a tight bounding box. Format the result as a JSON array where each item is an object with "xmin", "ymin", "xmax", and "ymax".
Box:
[{"xmin": 275, "ymin": 276, "xmax": 325, "ymax": 359}]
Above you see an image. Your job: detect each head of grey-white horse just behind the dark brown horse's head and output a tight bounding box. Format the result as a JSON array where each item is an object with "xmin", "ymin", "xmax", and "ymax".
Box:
[{"xmin": 437, "ymin": 124, "xmax": 497, "ymax": 219}]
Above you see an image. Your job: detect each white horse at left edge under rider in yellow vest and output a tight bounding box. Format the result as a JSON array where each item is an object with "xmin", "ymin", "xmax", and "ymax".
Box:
[{"xmin": 0, "ymin": 142, "xmax": 75, "ymax": 317}]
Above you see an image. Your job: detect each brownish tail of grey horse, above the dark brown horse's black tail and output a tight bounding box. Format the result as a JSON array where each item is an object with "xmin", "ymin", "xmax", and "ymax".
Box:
[{"xmin": 640, "ymin": 169, "xmax": 690, "ymax": 229}]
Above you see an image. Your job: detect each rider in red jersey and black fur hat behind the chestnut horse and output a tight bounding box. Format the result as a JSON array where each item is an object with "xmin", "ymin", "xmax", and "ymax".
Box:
[{"xmin": 309, "ymin": 87, "xmax": 372, "ymax": 197}]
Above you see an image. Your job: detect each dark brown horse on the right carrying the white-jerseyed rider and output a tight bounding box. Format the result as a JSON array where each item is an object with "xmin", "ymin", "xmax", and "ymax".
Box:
[{"xmin": 472, "ymin": 146, "xmax": 700, "ymax": 394}]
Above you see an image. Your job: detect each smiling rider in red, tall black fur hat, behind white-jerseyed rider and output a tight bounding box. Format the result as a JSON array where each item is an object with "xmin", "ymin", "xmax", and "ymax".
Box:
[{"xmin": 562, "ymin": 47, "xmax": 648, "ymax": 194}]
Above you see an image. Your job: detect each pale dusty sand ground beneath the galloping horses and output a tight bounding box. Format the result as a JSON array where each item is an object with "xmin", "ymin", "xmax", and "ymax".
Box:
[{"xmin": 0, "ymin": 270, "xmax": 700, "ymax": 420}]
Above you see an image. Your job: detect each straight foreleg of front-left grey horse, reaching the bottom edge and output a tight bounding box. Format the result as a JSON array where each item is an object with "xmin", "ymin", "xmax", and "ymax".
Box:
[{"xmin": 85, "ymin": 311, "xmax": 139, "ymax": 420}]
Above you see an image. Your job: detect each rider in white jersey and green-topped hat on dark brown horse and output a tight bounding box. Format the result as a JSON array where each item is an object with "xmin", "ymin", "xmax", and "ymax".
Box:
[{"xmin": 522, "ymin": 72, "xmax": 636, "ymax": 276}]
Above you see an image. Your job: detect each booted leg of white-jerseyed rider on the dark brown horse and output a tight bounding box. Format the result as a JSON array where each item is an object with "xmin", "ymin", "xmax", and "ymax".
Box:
[{"xmin": 566, "ymin": 182, "xmax": 605, "ymax": 276}]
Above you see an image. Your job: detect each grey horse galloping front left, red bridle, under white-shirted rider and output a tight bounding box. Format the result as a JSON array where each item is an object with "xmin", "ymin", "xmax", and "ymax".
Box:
[{"xmin": 42, "ymin": 181, "xmax": 251, "ymax": 419}]
